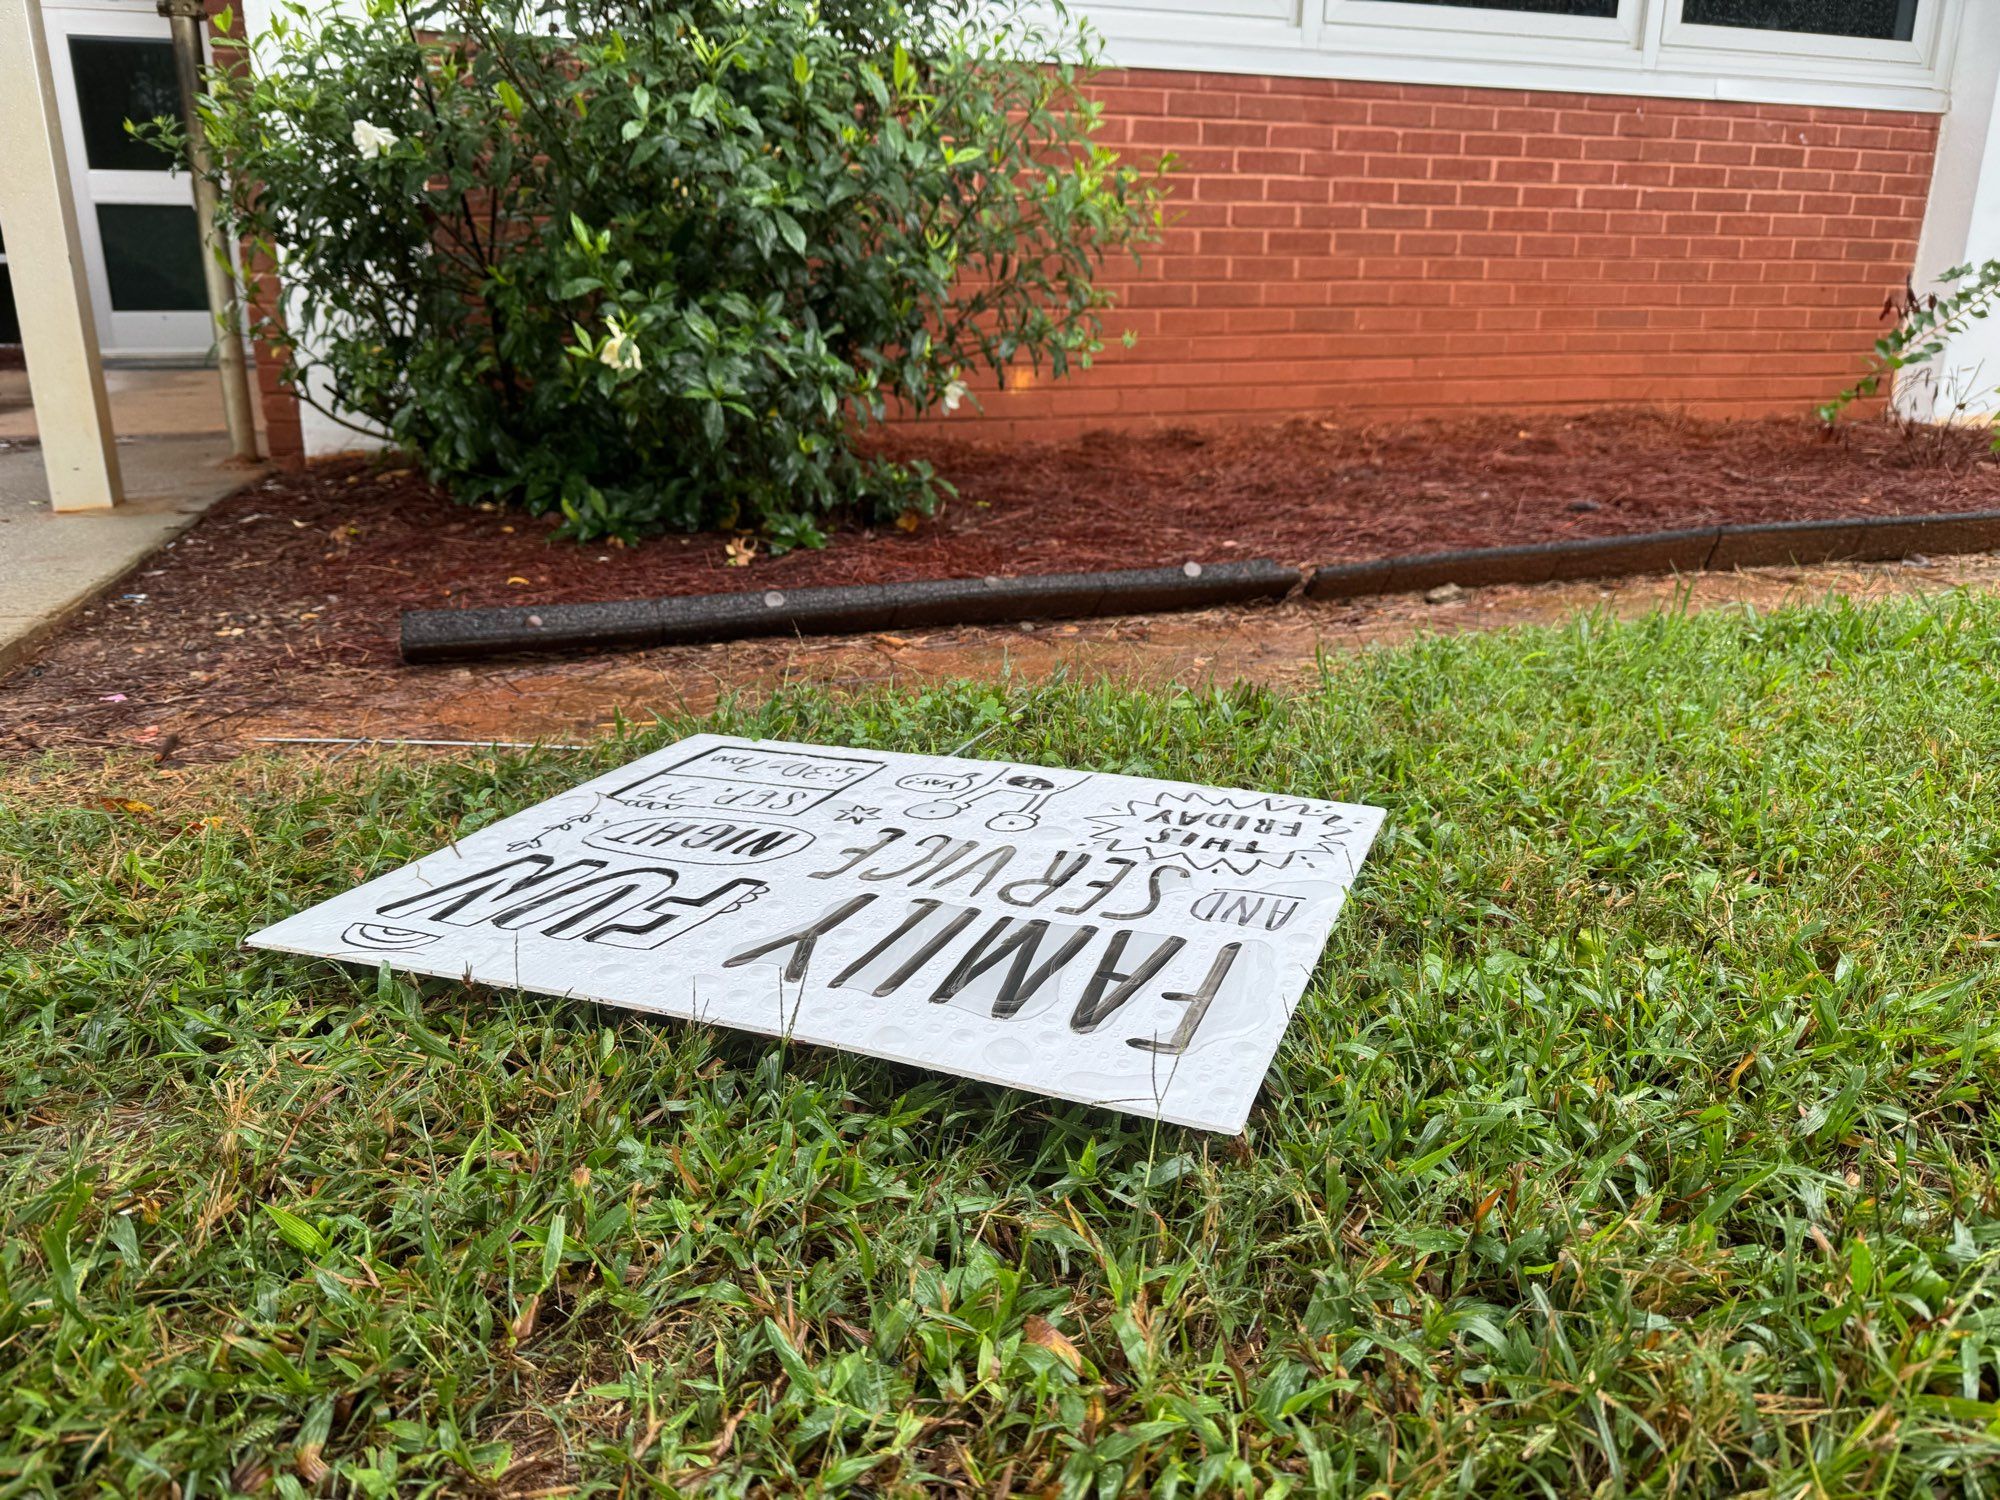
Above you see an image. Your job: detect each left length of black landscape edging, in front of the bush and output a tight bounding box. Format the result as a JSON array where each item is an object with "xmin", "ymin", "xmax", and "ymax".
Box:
[{"xmin": 402, "ymin": 558, "xmax": 1302, "ymax": 662}]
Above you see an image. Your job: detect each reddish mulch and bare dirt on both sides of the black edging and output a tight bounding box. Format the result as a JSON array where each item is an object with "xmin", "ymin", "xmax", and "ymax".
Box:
[{"xmin": 0, "ymin": 412, "xmax": 2000, "ymax": 756}]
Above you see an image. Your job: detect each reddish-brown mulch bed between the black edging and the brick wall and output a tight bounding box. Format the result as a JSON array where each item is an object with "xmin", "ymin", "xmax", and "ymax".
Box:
[{"xmin": 0, "ymin": 412, "xmax": 2000, "ymax": 744}]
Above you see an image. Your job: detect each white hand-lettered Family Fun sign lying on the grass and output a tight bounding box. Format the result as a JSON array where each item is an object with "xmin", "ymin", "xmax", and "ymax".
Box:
[{"xmin": 250, "ymin": 734, "xmax": 1382, "ymax": 1132}]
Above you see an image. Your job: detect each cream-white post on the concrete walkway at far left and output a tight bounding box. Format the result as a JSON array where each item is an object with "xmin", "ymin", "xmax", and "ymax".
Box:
[{"xmin": 0, "ymin": 0, "xmax": 122, "ymax": 510}]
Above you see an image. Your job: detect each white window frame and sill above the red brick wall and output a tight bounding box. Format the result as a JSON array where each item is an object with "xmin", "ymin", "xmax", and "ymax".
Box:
[{"xmin": 1072, "ymin": 0, "xmax": 1960, "ymax": 114}]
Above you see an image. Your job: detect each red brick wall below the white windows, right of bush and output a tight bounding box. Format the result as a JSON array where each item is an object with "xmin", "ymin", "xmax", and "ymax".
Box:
[{"xmin": 932, "ymin": 72, "xmax": 1938, "ymax": 438}]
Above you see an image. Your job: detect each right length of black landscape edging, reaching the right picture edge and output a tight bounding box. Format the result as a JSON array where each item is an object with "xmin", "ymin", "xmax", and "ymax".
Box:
[{"xmin": 1306, "ymin": 510, "xmax": 2000, "ymax": 598}]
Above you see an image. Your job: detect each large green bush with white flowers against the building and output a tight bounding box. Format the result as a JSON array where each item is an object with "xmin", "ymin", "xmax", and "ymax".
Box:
[{"xmin": 191, "ymin": 0, "xmax": 1160, "ymax": 548}]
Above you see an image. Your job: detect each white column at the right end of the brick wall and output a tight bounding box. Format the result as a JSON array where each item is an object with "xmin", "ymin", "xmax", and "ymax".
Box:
[{"xmin": 1896, "ymin": 0, "xmax": 2000, "ymax": 420}]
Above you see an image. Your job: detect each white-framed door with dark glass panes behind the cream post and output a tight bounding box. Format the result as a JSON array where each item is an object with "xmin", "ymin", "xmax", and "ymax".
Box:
[{"xmin": 42, "ymin": 4, "xmax": 216, "ymax": 358}]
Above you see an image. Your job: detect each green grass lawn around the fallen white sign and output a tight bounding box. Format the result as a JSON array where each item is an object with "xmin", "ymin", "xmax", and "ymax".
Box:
[{"xmin": 0, "ymin": 598, "xmax": 2000, "ymax": 1500}]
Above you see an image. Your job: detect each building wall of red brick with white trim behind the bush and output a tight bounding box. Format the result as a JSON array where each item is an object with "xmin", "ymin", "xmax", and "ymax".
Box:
[{"xmin": 230, "ymin": 0, "xmax": 1968, "ymax": 464}]
